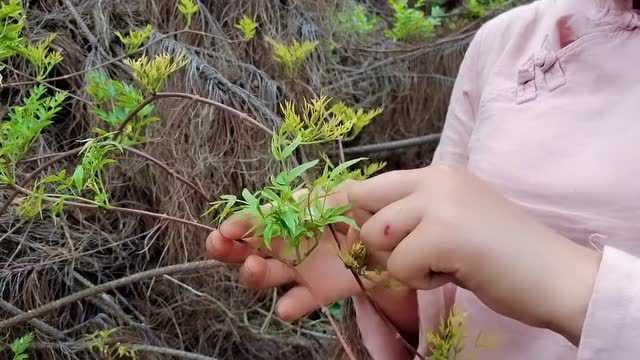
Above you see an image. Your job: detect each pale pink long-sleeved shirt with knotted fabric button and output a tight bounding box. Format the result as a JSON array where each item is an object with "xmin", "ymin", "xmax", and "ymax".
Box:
[{"xmin": 356, "ymin": 0, "xmax": 640, "ymax": 360}]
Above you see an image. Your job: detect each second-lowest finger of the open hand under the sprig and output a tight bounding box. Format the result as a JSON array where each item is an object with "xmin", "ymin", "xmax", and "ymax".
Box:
[{"xmin": 240, "ymin": 255, "xmax": 296, "ymax": 289}]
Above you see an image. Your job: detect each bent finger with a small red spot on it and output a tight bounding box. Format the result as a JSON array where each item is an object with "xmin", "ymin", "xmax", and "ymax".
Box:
[{"xmin": 360, "ymin": 196, "xmax": 422, "ymax": 251}]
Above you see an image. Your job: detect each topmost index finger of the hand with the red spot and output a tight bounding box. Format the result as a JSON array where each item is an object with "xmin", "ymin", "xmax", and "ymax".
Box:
[{"xmin": 346, "ymin": 169, "xmax": 421, "ymax": 212}]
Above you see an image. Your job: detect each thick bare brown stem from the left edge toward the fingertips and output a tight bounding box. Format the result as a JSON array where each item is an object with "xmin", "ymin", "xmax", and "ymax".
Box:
[{"xmin": 0, "ymin": 260, "xmax": 221, "ymax": 329}]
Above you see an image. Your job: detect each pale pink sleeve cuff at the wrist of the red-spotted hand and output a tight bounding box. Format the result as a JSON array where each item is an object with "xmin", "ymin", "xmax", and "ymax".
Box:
[{"xmin": 578, "ymin": 247, "xmax": 640, "ymax": 360}]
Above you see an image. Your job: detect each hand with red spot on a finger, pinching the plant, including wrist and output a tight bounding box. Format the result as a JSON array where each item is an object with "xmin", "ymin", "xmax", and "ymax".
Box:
[{"xmin": 348, "ymin": 166, "xmax": 600, "ymax": 343}]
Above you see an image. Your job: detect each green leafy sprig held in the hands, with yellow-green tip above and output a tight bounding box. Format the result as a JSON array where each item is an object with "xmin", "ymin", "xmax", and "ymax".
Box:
[{"xmin": 208, "ymin": 98, "xmax": 382, "ymax": 263}]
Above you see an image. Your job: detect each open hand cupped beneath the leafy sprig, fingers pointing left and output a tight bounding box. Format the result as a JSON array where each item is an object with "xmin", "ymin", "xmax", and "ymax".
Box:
[{"xmin": 202, "ymin": 192, "xmax": 418, "ymax": 333}]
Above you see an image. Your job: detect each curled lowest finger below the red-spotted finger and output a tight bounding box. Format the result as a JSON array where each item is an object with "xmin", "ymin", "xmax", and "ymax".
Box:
[{"xmin": 387, "ymin": 222, "xmax": 457, "ymax": 290}]
